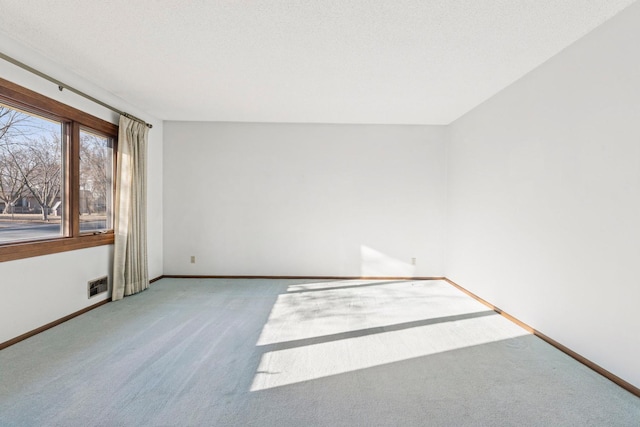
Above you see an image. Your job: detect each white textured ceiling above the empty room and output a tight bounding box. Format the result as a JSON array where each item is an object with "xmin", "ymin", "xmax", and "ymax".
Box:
[{"xmin": 0, "ymin": 0, "xmax": 635, "ymax": 124}]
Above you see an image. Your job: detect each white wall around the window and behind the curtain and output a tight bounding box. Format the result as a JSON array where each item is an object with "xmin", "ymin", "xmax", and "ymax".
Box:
[{"xmin": 0, "ymin": 35, "xmax": 163, "ymax": 343}]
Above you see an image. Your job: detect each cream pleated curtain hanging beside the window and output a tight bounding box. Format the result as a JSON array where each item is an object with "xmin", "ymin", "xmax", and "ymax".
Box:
[{"xmin": 112, "ymin": 116, "xmax": 149, "ymax": 301}]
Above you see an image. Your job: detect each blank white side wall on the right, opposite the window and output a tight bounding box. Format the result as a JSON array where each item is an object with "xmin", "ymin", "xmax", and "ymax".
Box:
[{"xmin": 446, "ymin": 4, "xmax": 640, "ymax": 392}]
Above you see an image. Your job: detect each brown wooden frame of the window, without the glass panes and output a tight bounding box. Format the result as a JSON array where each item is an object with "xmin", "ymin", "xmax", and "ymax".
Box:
[{"xmin": 0, "ymin": 78, "xmax": 118, "ymax": 262}]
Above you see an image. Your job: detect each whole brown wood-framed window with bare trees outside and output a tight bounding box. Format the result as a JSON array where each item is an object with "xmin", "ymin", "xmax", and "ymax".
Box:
[{"xmin": 0, "ymin": 79, "xmax": 117, "ymax": 261}]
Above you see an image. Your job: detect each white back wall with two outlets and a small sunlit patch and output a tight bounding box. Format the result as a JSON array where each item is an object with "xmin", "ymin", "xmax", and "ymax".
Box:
[{"xmin": 164, "ymin": 122, "xmax": 445, "ymax": 276}]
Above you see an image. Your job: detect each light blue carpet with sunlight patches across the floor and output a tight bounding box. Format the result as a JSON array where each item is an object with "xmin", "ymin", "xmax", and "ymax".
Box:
[{"xmin": 0, "ymin": 279, "xmax": 640, "ymax": 427}]
